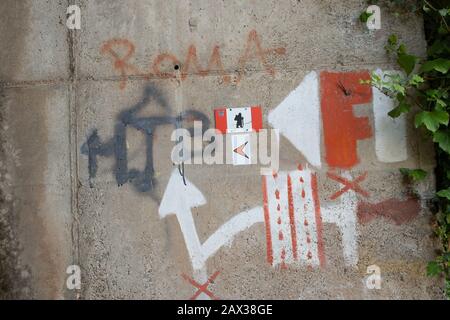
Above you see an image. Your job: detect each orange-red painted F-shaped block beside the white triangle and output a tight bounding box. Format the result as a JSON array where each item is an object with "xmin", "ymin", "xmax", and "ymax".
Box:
[{"xmin": 320, "ymin": 71, "xmax": 372, "ymax": 169}]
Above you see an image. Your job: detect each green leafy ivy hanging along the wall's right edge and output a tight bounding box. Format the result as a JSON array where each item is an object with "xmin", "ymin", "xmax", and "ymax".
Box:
[{"xmin": 363, "ymin": 0, "xmax": 450, "ymax": 298}]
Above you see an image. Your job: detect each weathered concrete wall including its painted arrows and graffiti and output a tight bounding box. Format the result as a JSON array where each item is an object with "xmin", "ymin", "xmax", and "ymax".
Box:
[{"xmin": 0, "ymin": 0, "xmax": 442, "ymax": 299}]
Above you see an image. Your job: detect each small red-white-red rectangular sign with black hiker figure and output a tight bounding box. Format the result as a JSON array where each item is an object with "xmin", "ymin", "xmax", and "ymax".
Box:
[{"xmin": 214, "ymin": 106, "xmax": 262, "ymax": 134}]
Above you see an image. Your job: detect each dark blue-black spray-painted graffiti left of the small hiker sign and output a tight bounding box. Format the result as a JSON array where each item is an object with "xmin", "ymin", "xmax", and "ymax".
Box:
[{"xmin": 81, "ymin": 85, "xmax": 209, "ymax": 192}]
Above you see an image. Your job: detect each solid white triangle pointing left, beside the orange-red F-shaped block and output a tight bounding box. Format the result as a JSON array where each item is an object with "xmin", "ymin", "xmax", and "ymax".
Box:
[{"xmin": 268, "ymin": 71, "xmax": 321, "ymax": 167}]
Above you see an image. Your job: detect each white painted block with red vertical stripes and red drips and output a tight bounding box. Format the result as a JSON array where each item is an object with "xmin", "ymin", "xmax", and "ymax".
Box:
[{"xmin": 263, "ymin": 169, "xmax": 325, "ymax": 268}]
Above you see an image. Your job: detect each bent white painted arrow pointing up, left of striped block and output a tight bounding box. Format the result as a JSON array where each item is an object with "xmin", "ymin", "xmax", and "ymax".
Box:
[{"xmin": 159, "ymin": 169, "xmax": 264, "ymax": 270}]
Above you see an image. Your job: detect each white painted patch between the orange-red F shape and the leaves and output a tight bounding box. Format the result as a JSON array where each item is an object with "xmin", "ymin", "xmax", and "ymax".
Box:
[{"xmin": 372, "ymin": 69, "xmax": 408, "ymax": 163}]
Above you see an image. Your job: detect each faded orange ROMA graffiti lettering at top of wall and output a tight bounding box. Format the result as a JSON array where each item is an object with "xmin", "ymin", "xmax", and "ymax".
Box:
[{"xmin": 100, "ymin": 30, "xmax": 286, "ymax": 89}]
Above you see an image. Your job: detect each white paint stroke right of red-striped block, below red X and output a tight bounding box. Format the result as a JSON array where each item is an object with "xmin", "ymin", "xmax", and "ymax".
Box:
[{"xmin": 322, "ymin": 172, "xmax": 359, "ymax": 266}]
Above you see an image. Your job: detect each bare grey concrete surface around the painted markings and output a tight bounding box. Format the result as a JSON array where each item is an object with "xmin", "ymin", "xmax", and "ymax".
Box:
[{"xmin": 0, "ymin": 0, "xmax": 443, "ymax": 299}]
